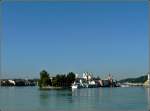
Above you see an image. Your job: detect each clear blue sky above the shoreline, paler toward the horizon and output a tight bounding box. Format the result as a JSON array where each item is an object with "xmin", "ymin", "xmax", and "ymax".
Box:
[{"xmin": 2, "ymin": 2, "xmax": 148, "ymax": 78}]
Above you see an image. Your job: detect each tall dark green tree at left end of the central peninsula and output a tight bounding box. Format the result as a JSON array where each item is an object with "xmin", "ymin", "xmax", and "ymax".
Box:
[{"xmin": 38, "ymin": 70, "xmax": 52, "ymax": 87}]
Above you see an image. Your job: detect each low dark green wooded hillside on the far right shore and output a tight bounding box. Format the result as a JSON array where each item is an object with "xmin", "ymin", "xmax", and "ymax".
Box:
[{"xmin": 119, "ymin": 75, "xmax": 147, "ymax": 83}]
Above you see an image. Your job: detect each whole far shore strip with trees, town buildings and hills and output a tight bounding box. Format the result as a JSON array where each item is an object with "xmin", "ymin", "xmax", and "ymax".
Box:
[{"xmin": 0, "ymin": 70, "xmax": 150, "ymax": 89}]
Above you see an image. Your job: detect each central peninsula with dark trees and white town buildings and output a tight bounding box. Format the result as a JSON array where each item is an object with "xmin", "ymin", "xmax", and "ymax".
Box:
[{"xmin": 38, "ymin": 70, "xmax": 119, "ymax": 90}]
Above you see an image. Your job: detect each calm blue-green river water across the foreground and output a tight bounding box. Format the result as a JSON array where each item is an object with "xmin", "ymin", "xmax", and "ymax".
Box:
[{"xmin": 0, "ymin": 87, "xmax": 150, "ymax": 111}]
